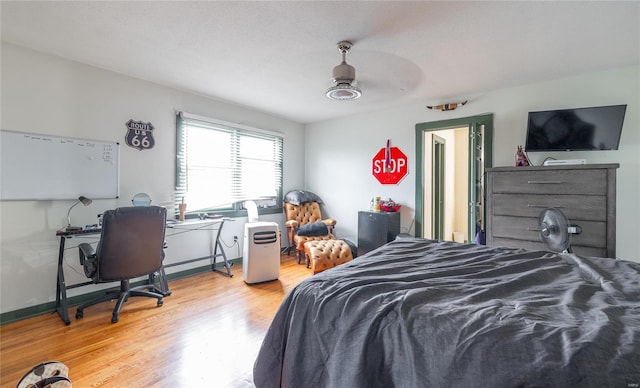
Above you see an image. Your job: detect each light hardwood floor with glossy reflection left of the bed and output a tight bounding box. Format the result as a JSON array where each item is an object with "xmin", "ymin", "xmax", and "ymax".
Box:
[{"xmin": 0, "ymin": 256, "xmax": 311, "ymax": 388}]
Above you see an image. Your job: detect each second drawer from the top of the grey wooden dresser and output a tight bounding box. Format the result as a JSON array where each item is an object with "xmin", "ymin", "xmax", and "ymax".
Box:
[{"xmin": 492, "ymin": 194, "xmax": 607, "ymax": 221}]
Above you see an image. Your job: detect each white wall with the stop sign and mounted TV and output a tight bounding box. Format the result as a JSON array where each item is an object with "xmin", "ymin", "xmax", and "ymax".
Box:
[{"xmin": 305, "ymin": 66, "xmax": 640, "ymax": 262}]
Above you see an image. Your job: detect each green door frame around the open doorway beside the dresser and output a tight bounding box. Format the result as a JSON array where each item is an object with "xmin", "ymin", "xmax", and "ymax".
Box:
[{"xmin": 414, "ymin": 113, "xmax": 493, "ymax": 241}]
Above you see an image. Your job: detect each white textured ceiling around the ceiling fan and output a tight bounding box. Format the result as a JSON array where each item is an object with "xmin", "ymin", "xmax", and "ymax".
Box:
[{"xmin": 1, "ymin": 0, "xmax": 640, "ymax": 123}]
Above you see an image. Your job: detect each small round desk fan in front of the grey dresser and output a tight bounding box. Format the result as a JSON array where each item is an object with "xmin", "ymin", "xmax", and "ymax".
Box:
[{"xmin": 538, "ymin": 208, "xmax": 582, "ymax": 253}]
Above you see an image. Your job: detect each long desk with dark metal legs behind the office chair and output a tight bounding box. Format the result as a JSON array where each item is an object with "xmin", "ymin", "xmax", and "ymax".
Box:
[{"xmin": 56, "ymin": 217, "xmax": 233, "ymax": 325}]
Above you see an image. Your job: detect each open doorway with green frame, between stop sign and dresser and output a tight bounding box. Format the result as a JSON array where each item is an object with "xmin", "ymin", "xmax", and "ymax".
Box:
[{"xmin": 415, "ymin": 114, "xmax": 493, "ymax": 242}]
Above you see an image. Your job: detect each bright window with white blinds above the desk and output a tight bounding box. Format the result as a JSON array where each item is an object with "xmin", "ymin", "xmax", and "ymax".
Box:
[{"xmin": 175, "ymin": 112, "xmax": 282, "ymax": 212}]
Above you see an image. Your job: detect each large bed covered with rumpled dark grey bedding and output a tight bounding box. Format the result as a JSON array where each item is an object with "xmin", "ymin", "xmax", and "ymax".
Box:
[{"xmin": 254, "ymin": 238, "xmax": 640, "ymax": 388}]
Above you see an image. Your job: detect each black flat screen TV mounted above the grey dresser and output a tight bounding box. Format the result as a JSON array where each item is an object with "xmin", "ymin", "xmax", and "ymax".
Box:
[{"xmin": 525, "ymin": 105, "xmax": 627, "ymax": 152}]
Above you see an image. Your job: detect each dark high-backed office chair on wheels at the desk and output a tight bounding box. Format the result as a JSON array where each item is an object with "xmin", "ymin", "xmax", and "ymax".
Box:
[{"xmin": 76, "ymin": 206, "xmax": 167, "ymax": 323}]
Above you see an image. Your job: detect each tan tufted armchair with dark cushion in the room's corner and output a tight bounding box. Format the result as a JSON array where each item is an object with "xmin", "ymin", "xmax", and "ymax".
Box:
[{"xmin": 284, "ymin": 190, "xmax": 336, "ymax": 264}]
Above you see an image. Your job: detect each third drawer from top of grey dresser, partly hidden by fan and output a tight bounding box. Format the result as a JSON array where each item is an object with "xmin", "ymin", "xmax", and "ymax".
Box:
[{"xmin": 492, "ymin": 216, "xmax": 607, "ymax": 248}]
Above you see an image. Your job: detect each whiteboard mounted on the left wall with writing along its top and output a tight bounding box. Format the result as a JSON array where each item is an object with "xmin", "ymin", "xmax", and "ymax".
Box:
[{"xmin": 0, "ymin": 130, "xmax": 120, "ymax": 200}]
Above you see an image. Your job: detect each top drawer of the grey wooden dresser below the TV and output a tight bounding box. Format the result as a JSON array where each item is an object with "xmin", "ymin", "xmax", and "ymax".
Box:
[{"xmin": 492, "ymin": 169, "xmax": 607, "ymax": 195}]
